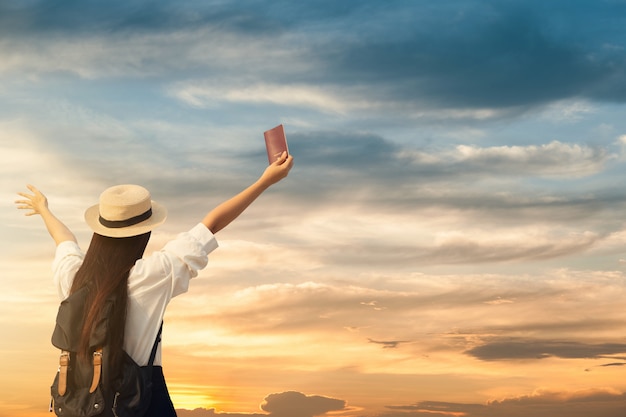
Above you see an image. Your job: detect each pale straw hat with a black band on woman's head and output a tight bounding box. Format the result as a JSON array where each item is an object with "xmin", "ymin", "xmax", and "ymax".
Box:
[{"xmin": 85, "ymin": 184, "xmax": 167, "ymax": 237}]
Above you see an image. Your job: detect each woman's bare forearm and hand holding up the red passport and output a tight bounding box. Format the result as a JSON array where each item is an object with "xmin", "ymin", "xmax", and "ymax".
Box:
[{"xmin": 202, "ymin": 152, "xmax": 293, "ymax": 233}]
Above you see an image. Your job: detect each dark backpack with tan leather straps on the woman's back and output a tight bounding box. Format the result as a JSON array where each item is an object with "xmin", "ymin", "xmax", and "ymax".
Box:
[{"xmin": 50, "ymin": 286, "xmax": 163, "ymax": 417}]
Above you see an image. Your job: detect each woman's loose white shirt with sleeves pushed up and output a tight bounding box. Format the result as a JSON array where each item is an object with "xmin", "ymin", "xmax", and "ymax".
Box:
[{"xmin": 52, "ymin": 223, "xmax": 218, "ymax": 366}]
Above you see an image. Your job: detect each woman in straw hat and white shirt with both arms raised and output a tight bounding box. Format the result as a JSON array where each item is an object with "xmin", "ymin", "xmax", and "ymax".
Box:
[{"xmin": 15, "ymin": 152, "xmax": 293, "ymax": 416}]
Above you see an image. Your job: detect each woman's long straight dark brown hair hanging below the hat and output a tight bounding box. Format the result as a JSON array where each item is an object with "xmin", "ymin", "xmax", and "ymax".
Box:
[{"xmin": 70, "ymin": 232, "xmax": 150, "ymax": 365}]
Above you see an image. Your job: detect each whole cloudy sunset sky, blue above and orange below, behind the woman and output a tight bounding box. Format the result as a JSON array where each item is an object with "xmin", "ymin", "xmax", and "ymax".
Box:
[{"xmin": 0, "ymin": 0, "xmax": 626, "ymax": 417}]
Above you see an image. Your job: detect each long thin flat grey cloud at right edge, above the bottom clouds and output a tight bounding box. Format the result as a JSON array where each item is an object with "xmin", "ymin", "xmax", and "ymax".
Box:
[{"xmin": 465, "ymin": 339, "xmax": 626, "ymax": 361}]
